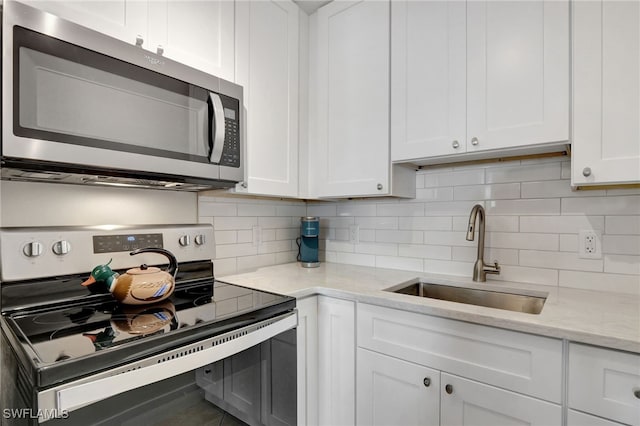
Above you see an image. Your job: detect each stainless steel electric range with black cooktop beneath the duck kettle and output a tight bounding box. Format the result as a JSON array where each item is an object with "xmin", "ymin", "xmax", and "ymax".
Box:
[{"xmin": 0, "ymin": 225, "xmax": 297, "ymax": 425}]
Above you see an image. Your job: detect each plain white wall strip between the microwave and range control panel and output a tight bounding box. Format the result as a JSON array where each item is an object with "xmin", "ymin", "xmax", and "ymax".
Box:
[{"xmin": 0, "ymin": 181, "xmax": 198, "ymax": 226}]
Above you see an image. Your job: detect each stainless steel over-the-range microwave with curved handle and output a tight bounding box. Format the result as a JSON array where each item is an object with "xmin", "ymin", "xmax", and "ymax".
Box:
[{"xmin": 1, "ymin": 0, "xmax": 244, "ymax": 190}]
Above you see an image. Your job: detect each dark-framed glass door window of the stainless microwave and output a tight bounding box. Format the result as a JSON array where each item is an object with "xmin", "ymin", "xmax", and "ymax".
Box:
[{"xmin": 13, "ymin": 27, "xmax": 238, "ymax": 163}]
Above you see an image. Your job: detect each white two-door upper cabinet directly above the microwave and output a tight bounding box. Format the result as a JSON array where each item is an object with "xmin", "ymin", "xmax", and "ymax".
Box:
[{"xmin": 25, "ymin": 0, "xmax": 235, "ymax": 81}]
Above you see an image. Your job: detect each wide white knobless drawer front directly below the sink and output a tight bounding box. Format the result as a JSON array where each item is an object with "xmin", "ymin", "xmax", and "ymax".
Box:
[{"xmin": 357, "ymin": 304, "xmax": 562, "ymax": 403}]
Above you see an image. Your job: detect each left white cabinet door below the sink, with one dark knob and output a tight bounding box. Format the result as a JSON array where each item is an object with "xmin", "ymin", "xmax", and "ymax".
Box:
[{"xmin": 356, "ymin": 348, "xmax": 440, "ymax": 426}]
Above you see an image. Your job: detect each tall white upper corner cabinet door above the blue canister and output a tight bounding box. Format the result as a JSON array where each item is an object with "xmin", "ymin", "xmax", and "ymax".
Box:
[{"xmin": 310, "ymin": 0, "xmax": 390, "ymax": 197}]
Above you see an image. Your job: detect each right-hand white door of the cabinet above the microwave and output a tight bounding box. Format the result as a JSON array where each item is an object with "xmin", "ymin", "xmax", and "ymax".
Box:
[{"xmin": 145, "ymin": 0, "xmax": 235, "ymax": 81}]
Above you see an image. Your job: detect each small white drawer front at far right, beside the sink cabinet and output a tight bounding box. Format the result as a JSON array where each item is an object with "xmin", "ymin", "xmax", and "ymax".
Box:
[{"xmin": 569, "ymin": 343, "xmax": 640, "ymax": 426}]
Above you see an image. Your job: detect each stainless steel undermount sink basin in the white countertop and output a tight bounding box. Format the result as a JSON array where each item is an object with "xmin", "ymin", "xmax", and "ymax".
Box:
[{"xmin": 386, "ymin": 281, "xmax": 547, "ymax": 314}]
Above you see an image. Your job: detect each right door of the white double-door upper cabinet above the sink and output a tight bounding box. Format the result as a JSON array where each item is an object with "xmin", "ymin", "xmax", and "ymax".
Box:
[{"xmin": 467, "ymin": 1, "xmax": 568, "ymax": 152}]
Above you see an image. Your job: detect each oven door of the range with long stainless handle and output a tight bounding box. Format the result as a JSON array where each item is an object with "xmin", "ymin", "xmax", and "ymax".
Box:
[{"xmin": 3, "ymin": 311, "xmax": 297, "ymax": 426}]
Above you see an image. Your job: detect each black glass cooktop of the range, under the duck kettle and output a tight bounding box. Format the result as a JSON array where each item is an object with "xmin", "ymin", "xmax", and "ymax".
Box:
[{"xmin": 2, "ymin": 280, "xmax": 295, "ymax": 388}]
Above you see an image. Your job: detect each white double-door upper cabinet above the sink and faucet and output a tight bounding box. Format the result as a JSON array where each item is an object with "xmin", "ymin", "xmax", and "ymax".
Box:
[{"xmin": 391, "ymin": 1, "xmax": 569, "ymax": 163}]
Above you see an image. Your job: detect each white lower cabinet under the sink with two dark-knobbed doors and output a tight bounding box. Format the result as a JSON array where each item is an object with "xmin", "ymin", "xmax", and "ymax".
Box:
[{"xmin": 356, "ymin": 303, "xmax": 562, "ymax": 426}]
